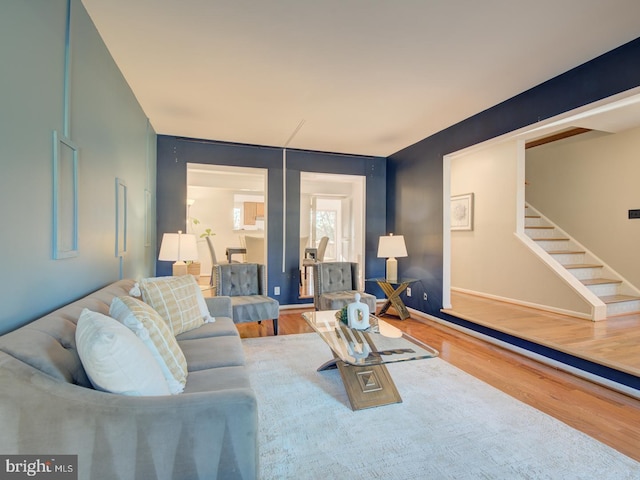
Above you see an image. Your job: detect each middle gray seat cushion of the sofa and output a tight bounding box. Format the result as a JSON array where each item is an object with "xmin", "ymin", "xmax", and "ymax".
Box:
[{"xmin": 180, "ymin": 336, "xmax": 245, "ymax": 375}]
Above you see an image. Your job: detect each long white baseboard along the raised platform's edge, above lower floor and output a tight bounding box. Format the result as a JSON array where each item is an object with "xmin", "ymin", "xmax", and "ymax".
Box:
[{"xmin": 409, "ymin": 308, "xmax": 640, "ymax": 400}]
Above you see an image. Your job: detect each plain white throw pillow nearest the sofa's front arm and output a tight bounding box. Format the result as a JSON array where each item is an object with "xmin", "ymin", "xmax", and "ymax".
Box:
[{"xmin": 76, "ymin": 308, "xmax": 170, "ymax": 396}]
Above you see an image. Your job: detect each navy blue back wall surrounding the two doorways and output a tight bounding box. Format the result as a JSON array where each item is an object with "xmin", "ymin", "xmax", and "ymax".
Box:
[{"xmin": 156, "ymin": 135, "xmax": 387, "ymax": 305}]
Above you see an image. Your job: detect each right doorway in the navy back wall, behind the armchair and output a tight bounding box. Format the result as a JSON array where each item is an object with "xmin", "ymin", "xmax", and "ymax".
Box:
[{"xmin": 300, "ymin": 172, "xmax": 365, "ymax": 298}]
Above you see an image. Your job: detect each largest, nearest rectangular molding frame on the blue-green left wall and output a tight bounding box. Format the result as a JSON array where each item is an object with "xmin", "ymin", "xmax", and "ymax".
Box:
[{"xmin": 52, "ymin": 130, "xmax": 78, "ymax": 260}]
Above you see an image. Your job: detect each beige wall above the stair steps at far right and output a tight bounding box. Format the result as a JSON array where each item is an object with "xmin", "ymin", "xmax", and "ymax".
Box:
[{"xmin": 526, "ymin": 128, "xmax": 640, "ymax": 287}]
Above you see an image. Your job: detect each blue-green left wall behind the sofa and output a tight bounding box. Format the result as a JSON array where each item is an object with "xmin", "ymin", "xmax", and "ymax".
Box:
[{"xmin": 0, "ymin": 0, "xmax": 156, "ymax": 332}]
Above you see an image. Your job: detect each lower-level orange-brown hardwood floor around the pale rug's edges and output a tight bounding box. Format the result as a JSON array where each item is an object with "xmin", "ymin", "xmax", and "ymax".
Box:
[{"xmin": 238, "ymin": 305, "xmax": 640, "ymax": 461}]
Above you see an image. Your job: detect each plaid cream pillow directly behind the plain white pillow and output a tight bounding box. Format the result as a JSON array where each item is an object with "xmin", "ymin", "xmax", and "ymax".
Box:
[{"xmin": 109, "ymin": 296, "xmax": 187, "ymax": 393}]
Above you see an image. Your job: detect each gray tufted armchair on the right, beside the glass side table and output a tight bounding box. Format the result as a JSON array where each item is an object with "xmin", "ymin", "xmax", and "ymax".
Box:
[{"xmin": 313, "ymin": 262, "xmax": 376, "ymax": 314}]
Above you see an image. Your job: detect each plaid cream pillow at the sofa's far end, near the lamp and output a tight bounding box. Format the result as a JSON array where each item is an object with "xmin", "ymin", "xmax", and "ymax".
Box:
[{"xmin": 140, "ymin": 275, "xmax": 206, "ymax": 336}]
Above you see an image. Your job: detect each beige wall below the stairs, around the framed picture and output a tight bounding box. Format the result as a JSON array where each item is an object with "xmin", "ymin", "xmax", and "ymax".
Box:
[{"xmin": 451, "ymin": 141, "xmax": 590, "ymax": 314}]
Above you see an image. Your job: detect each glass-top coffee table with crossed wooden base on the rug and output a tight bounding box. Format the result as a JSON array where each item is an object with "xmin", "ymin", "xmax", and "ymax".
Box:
[{"xmin": 302, "ymin": 310, "xmax": 438, "ymax": 410}]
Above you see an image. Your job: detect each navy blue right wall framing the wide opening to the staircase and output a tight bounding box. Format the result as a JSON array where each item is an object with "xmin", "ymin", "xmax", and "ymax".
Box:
[{"xmin": 387, "ymin": 38, "xmax": 640, "ymax": 318}]
